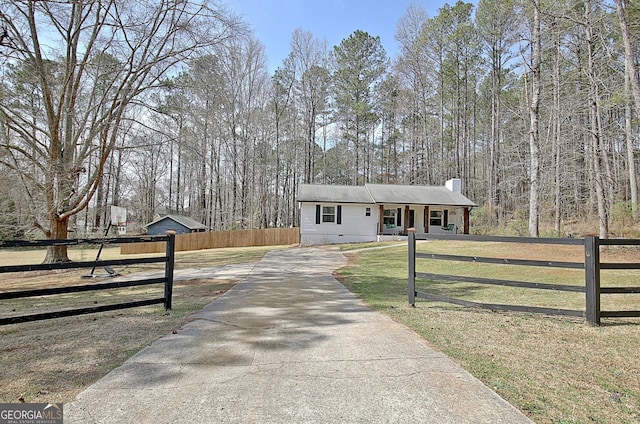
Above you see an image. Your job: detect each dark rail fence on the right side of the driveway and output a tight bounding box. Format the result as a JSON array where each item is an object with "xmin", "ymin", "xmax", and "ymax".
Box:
[{"xmin": 408, "ymin": 232, "xmax": 640, "ymax": 325}]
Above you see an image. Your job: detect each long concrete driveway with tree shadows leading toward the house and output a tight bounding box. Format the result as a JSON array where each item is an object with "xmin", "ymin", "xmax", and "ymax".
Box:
[{"xmin": 64, "ymin": 248, "xmax": 532, "ymax": 424}]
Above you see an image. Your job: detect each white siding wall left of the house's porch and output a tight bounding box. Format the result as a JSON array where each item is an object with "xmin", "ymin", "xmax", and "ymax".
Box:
[{"xmin": 300, "ymin": 203, "xmax": 378, "ymax": 246}]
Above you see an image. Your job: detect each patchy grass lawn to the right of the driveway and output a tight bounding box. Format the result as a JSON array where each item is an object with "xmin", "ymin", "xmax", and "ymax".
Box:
[{"xmin": 338, "ymin": 241, "xmax": 640, "ymax": 424}]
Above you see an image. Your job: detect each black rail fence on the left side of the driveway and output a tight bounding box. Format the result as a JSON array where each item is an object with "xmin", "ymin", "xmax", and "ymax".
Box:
[{"xmin": 0, "ymin": 233, "xmax": 175, "ymax": 325}]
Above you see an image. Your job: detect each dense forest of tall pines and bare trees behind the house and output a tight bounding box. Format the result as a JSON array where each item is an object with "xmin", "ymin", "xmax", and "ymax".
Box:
[{"xmin": 0, "ymin": 0, "xmax": 640, "ymax": 255}]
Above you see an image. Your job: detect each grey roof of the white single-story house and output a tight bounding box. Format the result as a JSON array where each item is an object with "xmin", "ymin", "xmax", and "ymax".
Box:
[{"xmin": 297, "ymin": 184, "xmax": 477, "ymax": 207}]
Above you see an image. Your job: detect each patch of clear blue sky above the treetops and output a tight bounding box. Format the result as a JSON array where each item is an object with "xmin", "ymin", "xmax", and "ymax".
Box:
[{"xmin": 223, "ymin": 0, "xmax": 477, "ymax": 71}]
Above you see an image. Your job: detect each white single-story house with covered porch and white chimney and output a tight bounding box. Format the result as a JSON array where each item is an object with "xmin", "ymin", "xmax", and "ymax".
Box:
[{"xmin": 297, "ymin": 178, "xmax": 477, "ymax": 246}]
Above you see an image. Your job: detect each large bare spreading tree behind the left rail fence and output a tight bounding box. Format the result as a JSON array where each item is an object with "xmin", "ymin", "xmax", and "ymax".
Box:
[{"xmin": 0, "ymin": 0, "xmax": 241, "ymax": 262}]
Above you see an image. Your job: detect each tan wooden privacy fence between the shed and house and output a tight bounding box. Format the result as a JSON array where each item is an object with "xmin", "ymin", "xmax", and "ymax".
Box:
[{"xmin": 120, "ymin": 228, "xmax": 300, "ymax": 255}]
